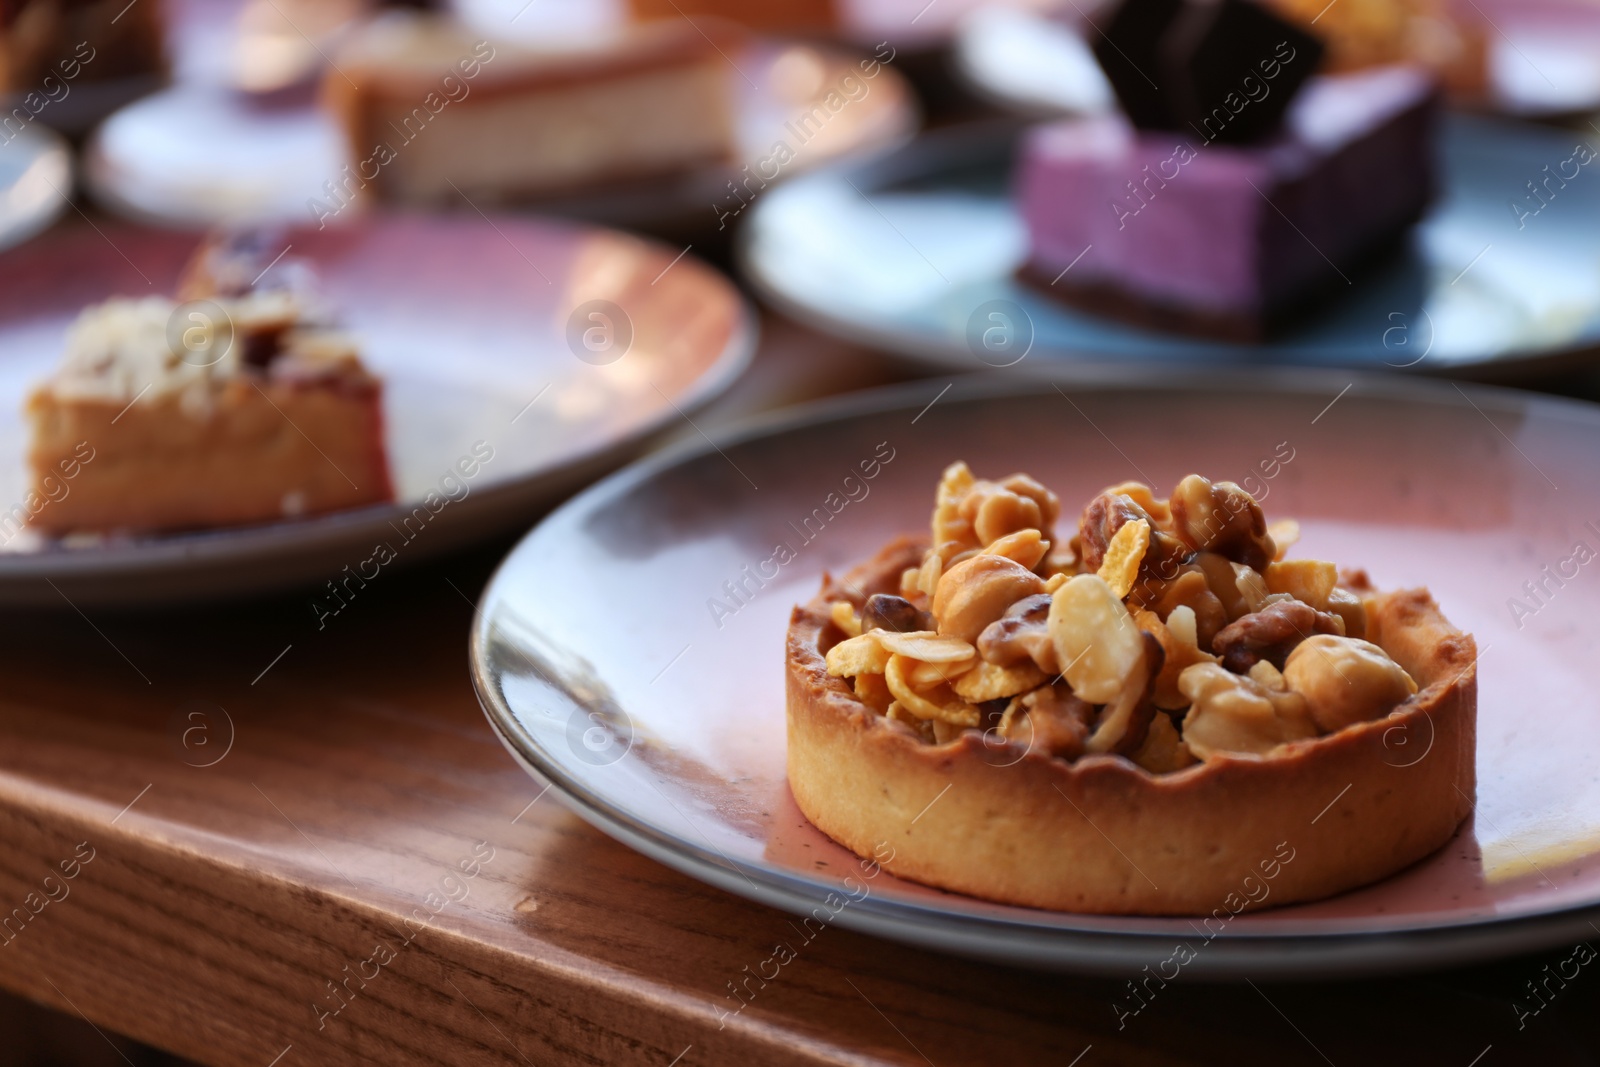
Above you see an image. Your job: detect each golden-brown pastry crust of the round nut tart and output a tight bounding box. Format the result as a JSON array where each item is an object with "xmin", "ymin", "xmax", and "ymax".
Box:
[{"xmin": 787, "ymin": 539, "xmax": 1477, "ymax": 915}]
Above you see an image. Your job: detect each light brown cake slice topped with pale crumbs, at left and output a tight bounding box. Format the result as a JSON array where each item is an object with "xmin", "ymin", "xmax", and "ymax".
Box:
[{"xmin": 27, "ymin": 232, "xmax": 392, "ymax": 534}]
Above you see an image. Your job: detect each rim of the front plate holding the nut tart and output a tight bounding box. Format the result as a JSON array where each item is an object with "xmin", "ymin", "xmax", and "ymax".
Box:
[{"xmin": 467, "ymin": 371, "xmax": 1600, "ymax": 981}]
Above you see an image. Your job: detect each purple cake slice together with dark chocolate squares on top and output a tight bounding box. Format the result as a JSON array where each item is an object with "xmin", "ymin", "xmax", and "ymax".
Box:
[{"xmin": 1018, "ymin": 0, "xmax": 1438, "ymax": 341}]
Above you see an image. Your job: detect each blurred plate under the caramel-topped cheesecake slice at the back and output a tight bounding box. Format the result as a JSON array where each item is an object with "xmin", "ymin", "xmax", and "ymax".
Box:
[{"xmin": 83, "ymin": 42, "xmax": 917, "ymax": 230}]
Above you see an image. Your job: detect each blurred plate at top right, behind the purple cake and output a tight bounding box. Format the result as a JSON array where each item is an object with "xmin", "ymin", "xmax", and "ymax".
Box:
[{"xmin": 954, "ymin": 0, "xmax": 1600, "ymax": 117}]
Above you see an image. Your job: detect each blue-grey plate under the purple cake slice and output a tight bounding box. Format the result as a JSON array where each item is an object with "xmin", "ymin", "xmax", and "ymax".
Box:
[{"xmin": 741, "ymin": 118, "xmax": 1600, "ymax": 373}]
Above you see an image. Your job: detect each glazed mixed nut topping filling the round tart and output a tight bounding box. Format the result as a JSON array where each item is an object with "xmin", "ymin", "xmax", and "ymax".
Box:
[{"xmin": 827, "ymin": 464, "xmax": 1416, "ymax": 773}]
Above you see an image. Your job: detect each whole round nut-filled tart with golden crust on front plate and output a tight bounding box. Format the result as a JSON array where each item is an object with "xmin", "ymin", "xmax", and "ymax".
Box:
[{"xmin": 787, "ymin": 462, "xmax": 1477, "ymax": 915}]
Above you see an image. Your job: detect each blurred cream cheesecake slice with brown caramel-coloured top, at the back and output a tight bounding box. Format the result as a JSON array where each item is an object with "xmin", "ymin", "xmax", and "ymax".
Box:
[{"xmin": 323, "ymin": 11, "xmax": 742, "ymax": 202}]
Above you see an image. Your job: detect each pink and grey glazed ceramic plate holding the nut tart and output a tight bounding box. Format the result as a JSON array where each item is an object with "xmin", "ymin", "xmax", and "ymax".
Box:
[{"xmin": 472, "ymin": 371, "xmax": 1600, "ymax": 977}]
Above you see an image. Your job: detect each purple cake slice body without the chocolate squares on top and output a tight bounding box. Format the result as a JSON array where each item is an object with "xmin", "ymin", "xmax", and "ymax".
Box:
[{"xmin": 1018, "ymin": 67, "xmax": 1437, "ymax": 341}]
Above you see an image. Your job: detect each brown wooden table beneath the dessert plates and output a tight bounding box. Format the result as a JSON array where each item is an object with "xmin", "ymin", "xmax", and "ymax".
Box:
[{"xmin": 0, "ymin": 323, "xmax": 1600, "ymax": 1067}]
